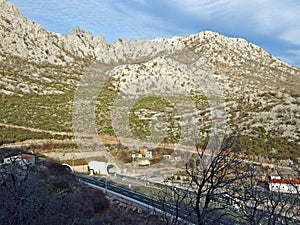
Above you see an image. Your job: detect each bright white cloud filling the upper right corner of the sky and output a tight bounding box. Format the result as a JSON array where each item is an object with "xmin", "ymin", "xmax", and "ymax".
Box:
[{"xmin": 170, "ymin": 0, "xmax": 300, "ymax": 38}]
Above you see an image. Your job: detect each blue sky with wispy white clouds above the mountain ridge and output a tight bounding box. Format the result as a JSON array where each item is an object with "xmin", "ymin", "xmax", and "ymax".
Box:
[{"xmin": 8, "ymin": 0, "xmax": 300, "ymax": 67}]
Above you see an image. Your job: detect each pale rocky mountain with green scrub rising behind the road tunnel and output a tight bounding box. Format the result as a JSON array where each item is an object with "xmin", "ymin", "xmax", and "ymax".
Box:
[{"xmin": 0, "ymin": 0, "xmax": 300, "ymax": 162}]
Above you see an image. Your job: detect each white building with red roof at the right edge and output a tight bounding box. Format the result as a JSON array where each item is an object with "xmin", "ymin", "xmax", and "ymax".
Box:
[{"xmin": 266, "ymin": 176, "xmax": 300, "ymax": 194}]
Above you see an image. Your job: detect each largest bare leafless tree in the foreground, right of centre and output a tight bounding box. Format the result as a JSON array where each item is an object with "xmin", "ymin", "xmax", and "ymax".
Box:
[{"xmin": 154, "ymin": 134, "xmax": 245, "ymax": 225}]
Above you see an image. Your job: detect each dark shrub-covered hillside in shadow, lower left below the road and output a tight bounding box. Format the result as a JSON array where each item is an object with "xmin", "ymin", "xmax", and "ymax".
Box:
[{"xmin": 0, "ymin": 148, "xmax": 160, "ymax": 225}]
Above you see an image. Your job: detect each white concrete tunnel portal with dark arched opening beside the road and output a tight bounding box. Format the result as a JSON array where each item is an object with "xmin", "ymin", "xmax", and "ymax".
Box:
[{"xmin": 88, "ymin": 161, "xmax": 121, "ymax": 176}]
